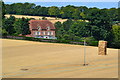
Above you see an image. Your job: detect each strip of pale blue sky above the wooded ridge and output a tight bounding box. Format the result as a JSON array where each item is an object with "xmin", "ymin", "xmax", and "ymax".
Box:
[{"xmin": 3, "ymin": 0, "xmax": 119, "ymax": 9}]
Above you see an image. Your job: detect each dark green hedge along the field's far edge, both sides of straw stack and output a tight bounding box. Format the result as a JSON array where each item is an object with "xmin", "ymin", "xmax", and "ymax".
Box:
[{"xmin": 2, "ymin": 36, "xmax": 120, "ymax": 49}]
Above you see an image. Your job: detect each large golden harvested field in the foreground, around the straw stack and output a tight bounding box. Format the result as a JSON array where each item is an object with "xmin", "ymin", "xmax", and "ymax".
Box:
[{"xmin": 1, "ymin": 39, "xmax": 118, "ymax": 78}]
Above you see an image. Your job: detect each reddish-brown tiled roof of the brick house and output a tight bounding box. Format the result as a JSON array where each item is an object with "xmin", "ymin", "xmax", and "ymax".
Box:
[{"xmin": 29, "ymin": 20, "xmax": 55, "ymax": 29}]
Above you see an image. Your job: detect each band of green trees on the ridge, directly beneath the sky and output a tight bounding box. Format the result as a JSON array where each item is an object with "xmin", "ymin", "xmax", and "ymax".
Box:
[{"xmin": 5, "ymin": 2, "xmax": 118, "ymax": 21}]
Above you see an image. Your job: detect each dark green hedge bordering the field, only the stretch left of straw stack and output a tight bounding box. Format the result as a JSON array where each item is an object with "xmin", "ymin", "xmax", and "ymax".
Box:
[{"xmin": 3, "ymin": 36, "xmax": 98, "ymax": 46}]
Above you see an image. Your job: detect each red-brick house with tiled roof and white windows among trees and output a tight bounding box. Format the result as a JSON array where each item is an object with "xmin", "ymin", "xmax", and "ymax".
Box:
[{"xmin": 26, "ymin": 20, "xmax": 56, "ymax": 39}]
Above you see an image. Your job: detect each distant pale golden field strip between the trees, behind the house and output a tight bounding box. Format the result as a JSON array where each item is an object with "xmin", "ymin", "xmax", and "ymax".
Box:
[{"xmin": 5, "ymin": 14, "xmax": 67, "ymax": 24}]
